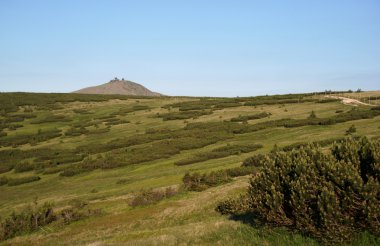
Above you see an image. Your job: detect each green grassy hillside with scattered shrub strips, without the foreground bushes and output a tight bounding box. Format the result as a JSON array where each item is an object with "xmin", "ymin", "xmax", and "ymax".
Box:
[{"xmin": 0, "ymin": 92, "xmax": 380, "ymax": 245}]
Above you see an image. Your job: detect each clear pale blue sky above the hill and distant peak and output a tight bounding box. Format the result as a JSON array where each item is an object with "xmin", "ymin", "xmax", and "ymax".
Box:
[{"xmin": 0, "ymin": 0, "xmax": 380, "ymax": 96}]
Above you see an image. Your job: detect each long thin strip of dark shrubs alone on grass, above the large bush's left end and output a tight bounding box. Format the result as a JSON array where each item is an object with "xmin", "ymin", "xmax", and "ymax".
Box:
[{"xmin": 176, "ymin": 144, "xmax": 263, "ymax": 166}]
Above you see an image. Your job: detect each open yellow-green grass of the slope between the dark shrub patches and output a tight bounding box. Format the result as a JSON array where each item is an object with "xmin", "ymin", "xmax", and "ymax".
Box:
[{"xmin": 0, "ymin": 92, "xmax": 380, "ymax": 245}]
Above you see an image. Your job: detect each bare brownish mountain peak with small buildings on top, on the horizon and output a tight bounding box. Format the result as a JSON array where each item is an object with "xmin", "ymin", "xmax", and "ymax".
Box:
[{"xmin": 73, "ymin": 77, "xmax": 162, "ymax": 96}]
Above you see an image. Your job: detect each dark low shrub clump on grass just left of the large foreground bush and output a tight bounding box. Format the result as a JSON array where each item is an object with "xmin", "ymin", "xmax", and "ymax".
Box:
[{"xmin": 182, "ymin": 170, "xmax": 231, "ymax": 191}]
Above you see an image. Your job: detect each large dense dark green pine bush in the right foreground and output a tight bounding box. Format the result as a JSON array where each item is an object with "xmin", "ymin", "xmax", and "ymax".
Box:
[{"xmin": 218, "ymin": 138, "xmax": 380, "ymax": 244}]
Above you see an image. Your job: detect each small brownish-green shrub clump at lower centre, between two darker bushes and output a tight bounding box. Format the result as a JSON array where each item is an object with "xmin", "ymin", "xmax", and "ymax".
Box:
[{"xmin": 129, "ymin": 187, "xmax": 178, "ymax": 207}]
